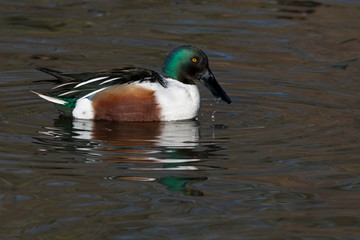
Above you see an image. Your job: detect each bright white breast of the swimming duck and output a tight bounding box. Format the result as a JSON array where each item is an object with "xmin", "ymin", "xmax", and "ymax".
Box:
[{"xmin": 136, "ymin": 78, "xmax": 200, "ymax": 121}]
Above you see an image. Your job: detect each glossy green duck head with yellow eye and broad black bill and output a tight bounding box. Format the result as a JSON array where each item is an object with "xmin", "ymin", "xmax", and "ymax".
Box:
[{"xmin": 162, "ymin": 45, "xmax": 231, "ymax": 103}]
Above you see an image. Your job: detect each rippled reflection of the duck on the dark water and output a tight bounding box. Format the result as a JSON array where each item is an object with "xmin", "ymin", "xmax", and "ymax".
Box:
[{"xmin": 43, "ymin": 118, "xmax": 207, "ymax": 196}]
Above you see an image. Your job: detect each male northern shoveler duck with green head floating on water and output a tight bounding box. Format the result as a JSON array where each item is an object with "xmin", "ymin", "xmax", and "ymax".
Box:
[{"xmin": 34, "ymin": 45, "xmax": 231, "ymax": 121}]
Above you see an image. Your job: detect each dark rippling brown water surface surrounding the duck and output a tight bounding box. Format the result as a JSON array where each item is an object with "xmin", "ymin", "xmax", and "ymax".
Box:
[{"xmin": 0, "ymin": 0, "xmax": 360, "ymax": 240}]
